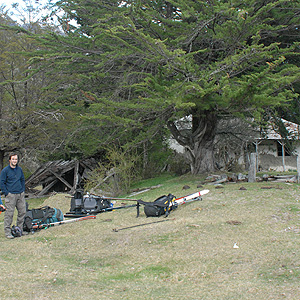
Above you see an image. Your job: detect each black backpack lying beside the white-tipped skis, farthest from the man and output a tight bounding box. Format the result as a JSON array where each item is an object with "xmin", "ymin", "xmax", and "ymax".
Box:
[{"xmin": 137, "ymin": 194, "xmax": 178, "ymax": 217}]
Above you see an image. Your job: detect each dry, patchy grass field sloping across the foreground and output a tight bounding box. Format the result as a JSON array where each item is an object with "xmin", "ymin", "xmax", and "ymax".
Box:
[{"xmin": 0, "ymin": 176, "xmax": 300, "ymax": 300}]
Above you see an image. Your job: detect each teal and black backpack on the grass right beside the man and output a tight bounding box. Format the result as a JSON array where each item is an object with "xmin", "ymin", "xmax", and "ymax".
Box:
[{"xmin": 23, "ymin": 205, "xmax": 64, "ymax": 232}]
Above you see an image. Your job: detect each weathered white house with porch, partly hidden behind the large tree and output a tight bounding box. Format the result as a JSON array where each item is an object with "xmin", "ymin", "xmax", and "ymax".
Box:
[{"xmin": 169, "ymin": 116, "xmax": 300, "ymax": 172}]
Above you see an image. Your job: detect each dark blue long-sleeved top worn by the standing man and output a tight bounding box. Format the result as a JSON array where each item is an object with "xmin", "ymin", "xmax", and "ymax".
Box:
[{"xmin": 0, "ymin": 165, "xmax": 25, "ymax": 201}]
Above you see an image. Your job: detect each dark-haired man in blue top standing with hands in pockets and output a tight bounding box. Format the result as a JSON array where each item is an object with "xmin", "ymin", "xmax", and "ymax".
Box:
[{"xmin": 0, "ymin": 153, "xmax": 26, "ymax": 239}]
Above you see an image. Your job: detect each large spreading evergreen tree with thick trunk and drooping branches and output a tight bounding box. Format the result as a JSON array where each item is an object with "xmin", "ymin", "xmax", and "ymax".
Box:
[{"xmin": 17, "ymin": 0, "xmax": 300, "ymax": 174}]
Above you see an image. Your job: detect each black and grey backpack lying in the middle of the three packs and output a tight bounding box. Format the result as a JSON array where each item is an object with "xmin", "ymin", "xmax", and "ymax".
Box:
[{"xmin": 70, "ymin": 191, "xmax": 112, "ymax": 214}]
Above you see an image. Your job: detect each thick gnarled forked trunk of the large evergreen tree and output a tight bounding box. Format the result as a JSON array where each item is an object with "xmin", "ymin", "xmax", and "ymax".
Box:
[{"xmin": 168, "ymin": 111, "xmax": 217, "ymax": 175}]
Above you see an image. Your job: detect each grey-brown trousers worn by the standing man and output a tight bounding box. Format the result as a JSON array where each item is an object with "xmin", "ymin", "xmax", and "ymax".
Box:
[{"xmin": 4, "ymin": 193, "xmax": 26, "ymax": 235}]
